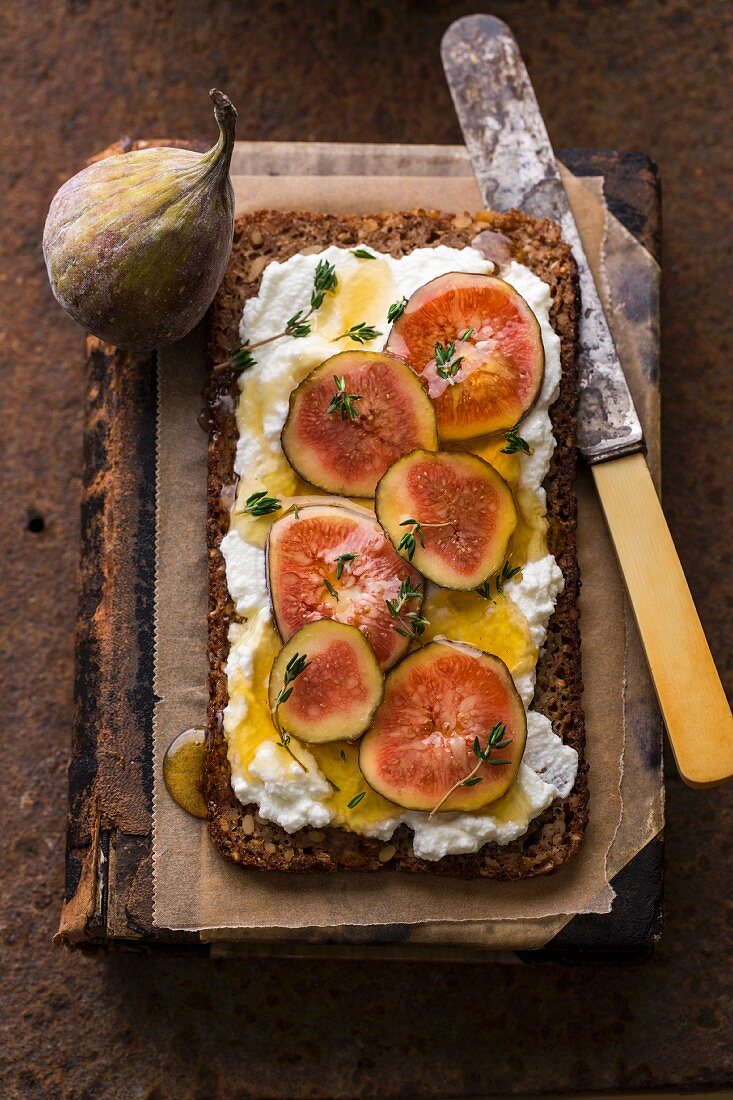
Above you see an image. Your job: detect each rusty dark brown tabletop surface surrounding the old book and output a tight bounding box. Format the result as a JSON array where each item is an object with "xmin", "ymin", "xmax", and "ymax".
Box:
[{"xmin": 0, "ymin": 0, "xmax": 733, "ymax": 1098}]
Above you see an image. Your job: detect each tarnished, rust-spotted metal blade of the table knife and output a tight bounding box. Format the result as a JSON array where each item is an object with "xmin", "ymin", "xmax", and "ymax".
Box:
[{"xmin": 441, "ymin": 15, "xmax": 644, "ymax": 462}]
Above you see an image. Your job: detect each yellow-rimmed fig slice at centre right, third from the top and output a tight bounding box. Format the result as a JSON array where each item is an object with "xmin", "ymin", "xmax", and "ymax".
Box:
[{"xmin": 375, "ymin": 451, "xmax": 517, "ymax": 590}]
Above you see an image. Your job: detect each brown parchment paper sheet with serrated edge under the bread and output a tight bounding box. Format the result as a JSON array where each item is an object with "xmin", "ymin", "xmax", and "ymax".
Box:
[{"xmin": 153, "ymin": 165, "xmax": 651, "ymax": 947}]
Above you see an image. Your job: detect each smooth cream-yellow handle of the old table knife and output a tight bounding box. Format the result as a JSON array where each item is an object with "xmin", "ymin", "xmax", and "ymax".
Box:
[{"xmin": 591, "ymin": 454, "xmax": 733, "ymax": 787}]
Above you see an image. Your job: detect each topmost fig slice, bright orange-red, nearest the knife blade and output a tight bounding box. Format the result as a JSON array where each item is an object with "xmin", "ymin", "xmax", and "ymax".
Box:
[{"xmin": 385, "ymin": 272, "xmax": 545, "ymax": 441}]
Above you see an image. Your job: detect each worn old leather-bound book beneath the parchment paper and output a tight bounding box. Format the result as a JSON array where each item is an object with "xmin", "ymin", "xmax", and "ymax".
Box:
[{"xmin": 61, "ymin": 142, "xmax": 661, "ymax": 960}]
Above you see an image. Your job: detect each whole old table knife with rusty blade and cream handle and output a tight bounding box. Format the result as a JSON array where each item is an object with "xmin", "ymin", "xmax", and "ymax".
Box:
[{"xmin": 441, "ymin": 15, "xmax": 733, "ymax": 787}]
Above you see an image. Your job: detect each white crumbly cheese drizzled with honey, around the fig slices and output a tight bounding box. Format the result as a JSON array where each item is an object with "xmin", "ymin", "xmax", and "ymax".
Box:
[{"xmin": 221, "ymin": 245, "xmax": 578, "ymax": 860}]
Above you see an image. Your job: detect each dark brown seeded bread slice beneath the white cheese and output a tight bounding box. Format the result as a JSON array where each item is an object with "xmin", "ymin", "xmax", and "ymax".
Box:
[{"xmin": 205, "ymin": 210, "xmax": 588, "ymax": 879}]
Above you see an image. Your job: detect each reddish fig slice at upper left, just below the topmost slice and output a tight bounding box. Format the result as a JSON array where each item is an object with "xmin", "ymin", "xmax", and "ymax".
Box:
[{"xmin": 282, "ymin": 351, "xmax": 438, "ymax": 497}]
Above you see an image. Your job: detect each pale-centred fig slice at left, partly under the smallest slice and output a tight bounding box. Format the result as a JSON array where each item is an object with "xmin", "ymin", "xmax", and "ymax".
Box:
[{"xmin": 266, "ymin": 504, "xmax": 423, "ymax": 669}]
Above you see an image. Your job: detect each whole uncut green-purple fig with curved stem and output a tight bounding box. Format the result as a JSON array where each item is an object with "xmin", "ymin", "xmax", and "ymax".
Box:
[{"xmin": 43, "ymin": 89, "xmax": 237, "ymax": 350}]
